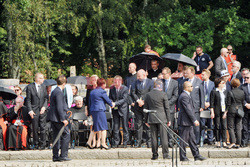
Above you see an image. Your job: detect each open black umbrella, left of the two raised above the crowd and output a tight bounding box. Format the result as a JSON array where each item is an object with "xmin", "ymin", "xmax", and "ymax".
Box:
[{"xmin": 129, "ymin": 52, "xmax": 165, "ymax": 71}]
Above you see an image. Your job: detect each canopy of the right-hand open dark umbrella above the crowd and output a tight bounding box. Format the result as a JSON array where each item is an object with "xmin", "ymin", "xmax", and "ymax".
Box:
[{"xmin": 161, "ymin": 53, "xmax": 197, "ymax": 67}]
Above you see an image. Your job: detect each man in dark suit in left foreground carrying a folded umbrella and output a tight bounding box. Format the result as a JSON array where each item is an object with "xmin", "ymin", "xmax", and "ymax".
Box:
[{"xmin": 47, "ymin": 75, "xmax": 71, "ymax": 162}]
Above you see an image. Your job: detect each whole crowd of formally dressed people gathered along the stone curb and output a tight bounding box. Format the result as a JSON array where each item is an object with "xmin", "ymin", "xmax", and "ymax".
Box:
[{"xmin": 0, "ymin": 45, "xmax": 250, "ymax": 161}]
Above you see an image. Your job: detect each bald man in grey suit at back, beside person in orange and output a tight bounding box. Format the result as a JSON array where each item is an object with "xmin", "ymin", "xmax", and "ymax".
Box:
[{"xmin": 215, "ymin": 48, "xmax": 228, "ymax": 77}]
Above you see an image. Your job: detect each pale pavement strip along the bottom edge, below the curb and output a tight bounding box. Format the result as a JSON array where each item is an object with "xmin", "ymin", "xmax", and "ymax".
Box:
[{"xmin": 0, "ymin": 158, "xmax": 250, "ymax": 167}]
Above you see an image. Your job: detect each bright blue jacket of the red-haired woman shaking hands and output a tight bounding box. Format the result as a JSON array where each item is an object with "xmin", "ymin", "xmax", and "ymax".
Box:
[{"xmin": 89, "ymin": 87, "xmax": 112, "ymax": 112}]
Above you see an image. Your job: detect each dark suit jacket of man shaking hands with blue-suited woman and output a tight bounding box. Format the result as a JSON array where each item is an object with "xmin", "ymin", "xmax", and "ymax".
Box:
[{"xmin": 109, "ymin": 85, "xmax": 128, "ymax": 116}]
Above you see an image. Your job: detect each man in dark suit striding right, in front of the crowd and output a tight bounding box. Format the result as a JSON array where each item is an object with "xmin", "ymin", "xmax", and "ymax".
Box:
[{"xmin": 178, "ymin": 81, "xmax": 206, "ymax": 161}]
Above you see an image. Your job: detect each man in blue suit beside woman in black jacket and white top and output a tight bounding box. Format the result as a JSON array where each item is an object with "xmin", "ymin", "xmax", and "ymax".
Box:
[{"xmin": 200, "ymin": 69, "xmax": 214, "ymax": 146}]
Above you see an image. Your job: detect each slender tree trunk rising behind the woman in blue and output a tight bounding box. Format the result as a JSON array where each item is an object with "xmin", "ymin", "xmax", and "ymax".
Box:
[{"xmin": 96, "ymin": 2, "xmax": 108, "ymax": 79}]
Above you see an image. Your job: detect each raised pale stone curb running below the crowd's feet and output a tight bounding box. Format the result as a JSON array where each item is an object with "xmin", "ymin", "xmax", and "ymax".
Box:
[{"xmin": 0, "ymin": 147, "xmax": 250, "ymax": 161}]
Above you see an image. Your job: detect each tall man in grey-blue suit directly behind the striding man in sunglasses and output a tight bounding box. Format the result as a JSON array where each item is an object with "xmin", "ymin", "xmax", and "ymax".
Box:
[{"xmin": 187, "ymin": 67, "xmax": 205, "ymax": 144}]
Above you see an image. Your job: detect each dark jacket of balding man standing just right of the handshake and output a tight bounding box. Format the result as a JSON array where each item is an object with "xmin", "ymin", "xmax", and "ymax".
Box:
[{"xmin": 131, "ymin": 78, "xmax": 154, "ymax": 110}]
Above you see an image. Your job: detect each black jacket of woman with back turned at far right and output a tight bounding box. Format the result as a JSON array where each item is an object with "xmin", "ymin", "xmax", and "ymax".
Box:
[{"xmin": 226, "ymin": 88, "xmax": 245, "ymax": 113}]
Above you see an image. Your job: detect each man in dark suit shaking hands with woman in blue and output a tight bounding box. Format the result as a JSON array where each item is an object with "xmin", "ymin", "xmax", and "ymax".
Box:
[{"xmin": 109, "ymin": 75, "xmax": 129, "ymax": 148}]
